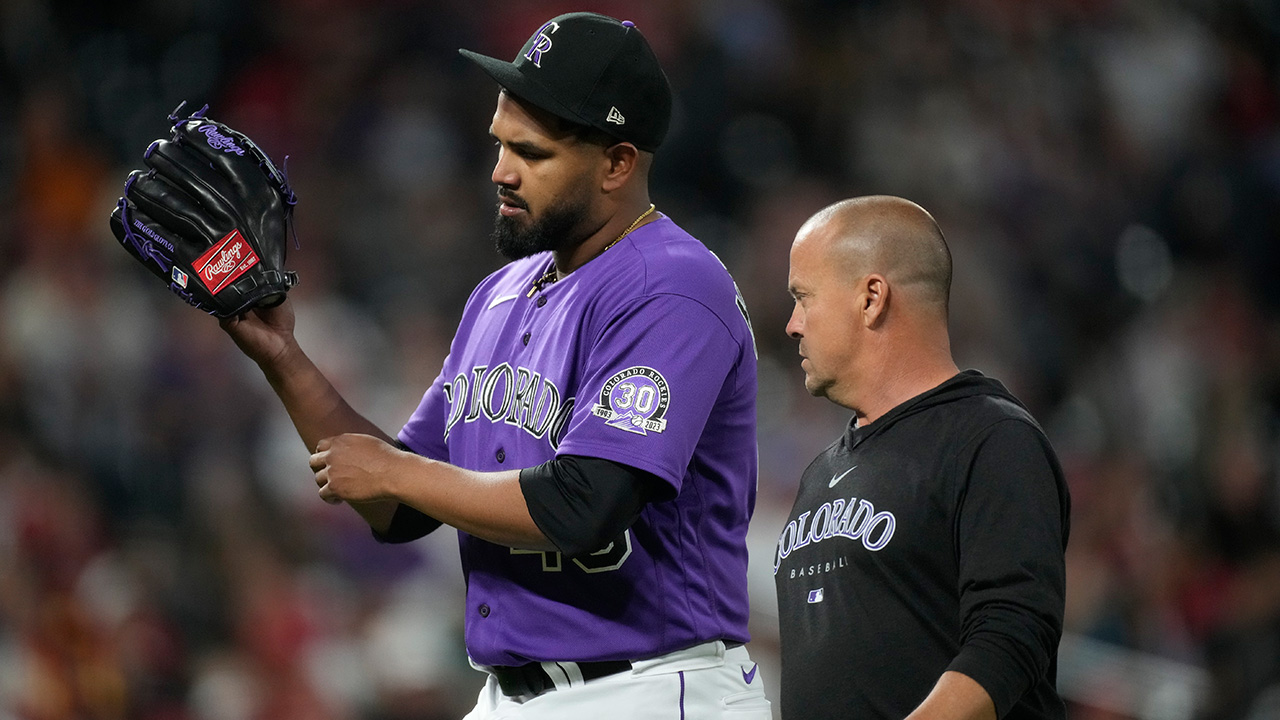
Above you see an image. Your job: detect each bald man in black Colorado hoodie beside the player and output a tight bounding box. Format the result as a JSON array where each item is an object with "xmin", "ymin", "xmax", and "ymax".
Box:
[{"xmin": 773, "ymin": 196, "xmax": 1070, "ymax": 720}]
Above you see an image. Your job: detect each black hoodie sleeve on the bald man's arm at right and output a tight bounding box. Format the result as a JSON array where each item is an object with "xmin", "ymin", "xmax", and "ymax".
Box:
[{"xmin": 947, "ymin": 419, "xmax": 1070, "ymax": 717}]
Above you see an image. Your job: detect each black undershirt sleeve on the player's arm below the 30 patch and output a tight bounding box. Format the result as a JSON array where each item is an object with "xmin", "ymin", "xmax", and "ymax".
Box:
[{"xmin": 520, "ymin": 455, "xmax": 675, "ymax": 557}]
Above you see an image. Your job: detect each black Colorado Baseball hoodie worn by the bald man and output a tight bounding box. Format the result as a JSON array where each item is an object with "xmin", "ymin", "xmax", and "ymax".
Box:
[{"xmin": 774, "ymin": 370, "xmax": 1070, "ymax": 720}]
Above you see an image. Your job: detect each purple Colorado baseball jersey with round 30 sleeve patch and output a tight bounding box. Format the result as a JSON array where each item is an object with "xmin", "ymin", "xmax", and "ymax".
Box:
[{"xmin": 399, "ymin": 217, "xmax": 756, "ymax": 665}]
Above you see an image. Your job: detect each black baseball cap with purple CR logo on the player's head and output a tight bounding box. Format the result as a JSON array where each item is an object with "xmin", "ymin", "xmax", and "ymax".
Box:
[{"xmin": 458, "ymin": 13, "xmax": 671, "ymax": 152}]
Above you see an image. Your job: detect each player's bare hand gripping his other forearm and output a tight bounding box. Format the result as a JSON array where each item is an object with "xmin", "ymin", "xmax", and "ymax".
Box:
[{"xmin": 310, "ymin": 433, "xmax": 406, "ymax": 503}]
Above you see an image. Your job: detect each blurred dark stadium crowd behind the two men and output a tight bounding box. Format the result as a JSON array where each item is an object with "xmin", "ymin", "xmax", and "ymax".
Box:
[{"xmin": 0, "ymin": 0, "xmax": 1280, "ymax": 720}]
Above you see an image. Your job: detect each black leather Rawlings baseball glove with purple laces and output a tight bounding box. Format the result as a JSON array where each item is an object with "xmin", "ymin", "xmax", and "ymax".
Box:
[{"xmin": 110, "ymin": 102, "xmax": 298, "ymax": 318}]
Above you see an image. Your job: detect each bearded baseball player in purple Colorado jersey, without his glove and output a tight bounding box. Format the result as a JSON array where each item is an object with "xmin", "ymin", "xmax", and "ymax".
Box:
[{"xmin": 223, "ymin": 13, "xmax": 771, "ymax": 720}]
